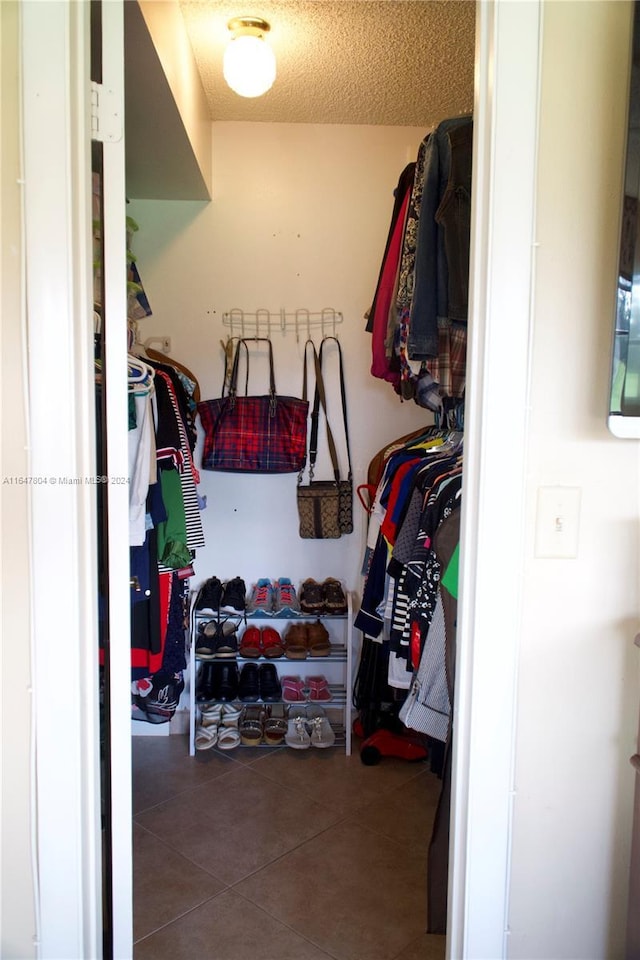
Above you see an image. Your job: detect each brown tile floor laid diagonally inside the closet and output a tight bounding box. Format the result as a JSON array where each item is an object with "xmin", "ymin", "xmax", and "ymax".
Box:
[{"xmin": 133, "ymin": 735, "xmax": 445, "ymax": 960}]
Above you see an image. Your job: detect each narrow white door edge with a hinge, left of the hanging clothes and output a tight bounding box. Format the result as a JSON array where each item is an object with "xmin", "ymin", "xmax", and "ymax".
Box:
[{"xmin": 102, "ymin": 0, "xmax": 133, "ymax": 960}]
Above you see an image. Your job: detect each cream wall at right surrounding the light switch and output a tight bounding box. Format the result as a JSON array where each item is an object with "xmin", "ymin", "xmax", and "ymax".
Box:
[{"xmin": 504, "ymin": 2, "xmax": 640, "ymax": 960}]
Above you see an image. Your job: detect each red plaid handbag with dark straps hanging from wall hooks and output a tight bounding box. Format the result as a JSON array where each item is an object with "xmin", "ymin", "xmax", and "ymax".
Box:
[{"xmin": 198, "ymin": 337, "xmax": 309, "ymax": 473}]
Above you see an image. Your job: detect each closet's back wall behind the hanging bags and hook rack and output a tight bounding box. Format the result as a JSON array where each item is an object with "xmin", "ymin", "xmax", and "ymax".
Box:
[{"xmin": 129, "ymin": 123, "xmax": 432, "ymax": 588}]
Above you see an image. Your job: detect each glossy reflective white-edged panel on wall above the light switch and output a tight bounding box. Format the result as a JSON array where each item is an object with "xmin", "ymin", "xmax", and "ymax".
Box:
[{"xmin": 608, "ymin": 0, "xmax": 640, "ymax": 438}]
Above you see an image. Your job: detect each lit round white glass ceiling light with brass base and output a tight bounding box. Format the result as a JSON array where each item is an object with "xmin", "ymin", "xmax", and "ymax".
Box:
[{"xmin": 222, "ymin": 17, "xmax": 276, "ymax": 97}]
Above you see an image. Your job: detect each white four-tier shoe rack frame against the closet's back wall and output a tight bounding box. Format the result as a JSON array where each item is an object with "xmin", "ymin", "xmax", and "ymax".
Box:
[{"xmin": 189, "ymin": 591, "xmax": 353, "ymax": 757}]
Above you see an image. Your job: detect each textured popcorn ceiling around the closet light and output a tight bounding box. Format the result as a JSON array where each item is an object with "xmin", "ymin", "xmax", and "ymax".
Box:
[{"xmin": 180, "ymin": 0, "xmax": 475, "ymax": 126}]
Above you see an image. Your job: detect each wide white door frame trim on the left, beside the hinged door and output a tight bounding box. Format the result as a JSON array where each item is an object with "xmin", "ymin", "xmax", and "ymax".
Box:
[{"xmin": 20, "ymin": 2, "xmax": 102, "ymax": 960}]
